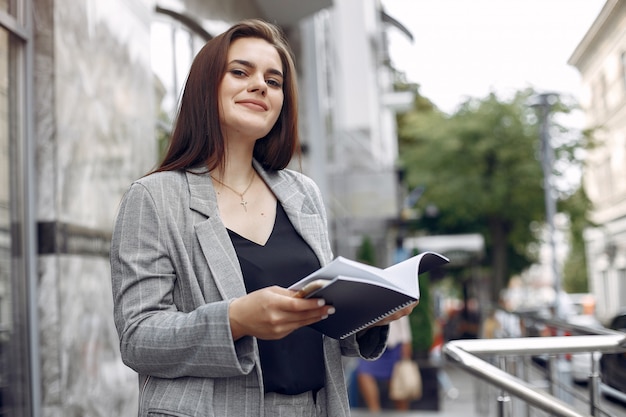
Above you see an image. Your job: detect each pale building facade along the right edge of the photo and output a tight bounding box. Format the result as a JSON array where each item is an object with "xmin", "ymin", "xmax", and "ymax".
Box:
[{"xmin": 569, "ymin": 0, "xmax": 626, "ymax": 321}]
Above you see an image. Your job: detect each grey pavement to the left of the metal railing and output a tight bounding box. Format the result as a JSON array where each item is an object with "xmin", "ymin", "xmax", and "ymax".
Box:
[{"xmin": 352, "ymin": 363, "xmax": 480, "ymax": 417}]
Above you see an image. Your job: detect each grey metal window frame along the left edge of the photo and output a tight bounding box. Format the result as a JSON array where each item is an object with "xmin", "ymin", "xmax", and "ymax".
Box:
[{"xmin": 0, "ymin": 0, "xmax": 41, "ymax": 417}]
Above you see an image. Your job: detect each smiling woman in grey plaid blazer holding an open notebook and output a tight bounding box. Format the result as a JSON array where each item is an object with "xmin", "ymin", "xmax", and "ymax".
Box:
[{"xmin": 111, "ymin": 20, "xmax": 412, "ymax": 417}]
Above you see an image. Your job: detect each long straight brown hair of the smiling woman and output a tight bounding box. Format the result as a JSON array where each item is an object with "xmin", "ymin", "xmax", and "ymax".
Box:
[{"xmin": 154, "ymin": 19, "xmax": 300, "ymax": 172}]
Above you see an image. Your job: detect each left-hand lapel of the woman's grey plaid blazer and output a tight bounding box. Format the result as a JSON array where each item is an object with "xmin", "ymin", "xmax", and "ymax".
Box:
[{"xmin": 186, "ymin": 171, "xmax": 246, "ymax": 300}]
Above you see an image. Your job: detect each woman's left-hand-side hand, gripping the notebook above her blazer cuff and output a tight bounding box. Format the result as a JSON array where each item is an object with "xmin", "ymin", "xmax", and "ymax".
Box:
[{"xmin": 229, "ymin": 286, "xmax": 335, "ymax": 340}]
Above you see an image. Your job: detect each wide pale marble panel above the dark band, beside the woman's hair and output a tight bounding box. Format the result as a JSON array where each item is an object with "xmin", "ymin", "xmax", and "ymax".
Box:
[{"xmin": 54, "ymin": 0, "xmax": 157, "ymax": 229}]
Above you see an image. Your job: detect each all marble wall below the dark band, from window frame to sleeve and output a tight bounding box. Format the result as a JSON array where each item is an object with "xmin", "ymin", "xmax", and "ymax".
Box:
[{"xmin": 39, "ymin": 256, "xmax": 138, "ymax": 417}]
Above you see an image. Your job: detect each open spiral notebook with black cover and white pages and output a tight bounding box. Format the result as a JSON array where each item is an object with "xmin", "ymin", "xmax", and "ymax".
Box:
[{"xmin": 289, "ymin": 252, "xmax": 449, "ymax": 339}]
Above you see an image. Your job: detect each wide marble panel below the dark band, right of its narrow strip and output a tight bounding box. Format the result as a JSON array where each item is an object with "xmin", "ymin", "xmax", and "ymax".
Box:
[{"xmin": 58, "ymin": 256, "xmax": 138, "ymax": 417}]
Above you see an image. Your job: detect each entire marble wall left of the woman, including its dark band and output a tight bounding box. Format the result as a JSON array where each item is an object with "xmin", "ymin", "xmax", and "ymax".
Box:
[{"xmin": 34, "ymin": 0, "xmax": 156, "ymax": 417}]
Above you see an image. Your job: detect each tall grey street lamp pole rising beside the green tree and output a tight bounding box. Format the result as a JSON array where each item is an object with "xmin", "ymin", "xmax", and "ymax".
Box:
[{"xmin": 533, "ymin": 93, "xmax": 562, "ymax": 319}]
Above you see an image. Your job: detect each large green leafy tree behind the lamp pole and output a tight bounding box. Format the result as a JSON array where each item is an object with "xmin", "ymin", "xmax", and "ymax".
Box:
[{"xmin": 398, "ymin": 90, "xmax": 582, "ymax": 299}]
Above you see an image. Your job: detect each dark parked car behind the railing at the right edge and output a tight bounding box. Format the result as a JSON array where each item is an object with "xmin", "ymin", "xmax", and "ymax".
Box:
[{"xmin": 600, "ymin": 310, "xmax": 626, "ymax": 404}]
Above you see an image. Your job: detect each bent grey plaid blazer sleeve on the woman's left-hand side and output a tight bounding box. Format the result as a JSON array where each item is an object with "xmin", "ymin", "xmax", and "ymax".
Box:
[{"xmin": 110, "ymin": 183, "xmax": 254, "ymax": 378}]
